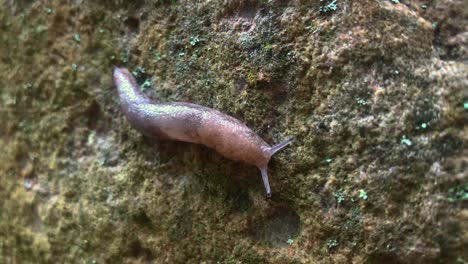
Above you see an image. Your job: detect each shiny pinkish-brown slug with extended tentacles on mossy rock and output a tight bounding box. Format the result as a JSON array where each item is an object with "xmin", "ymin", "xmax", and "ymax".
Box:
[{"xmin": 114, "ymin": 67, "xmax": 293, "ymax": 197}]
